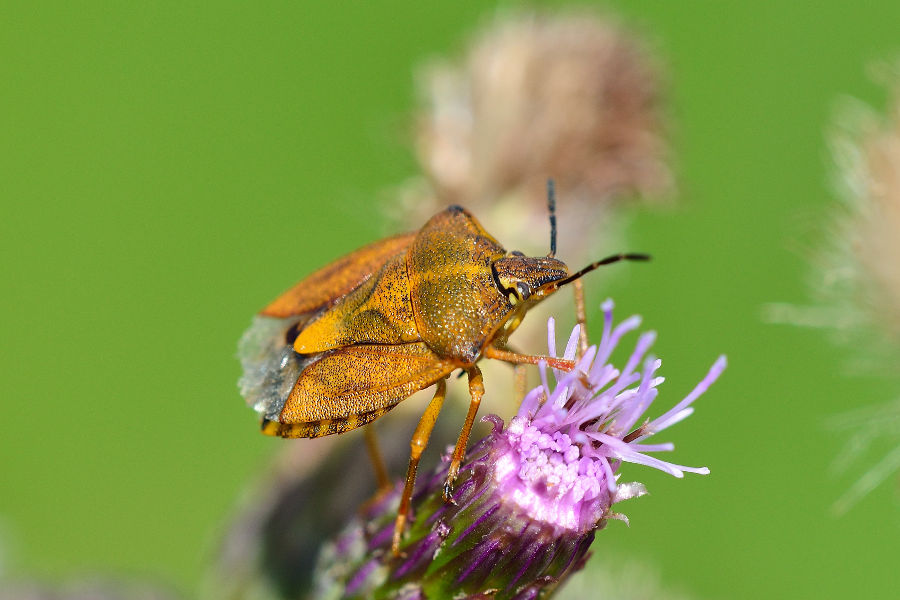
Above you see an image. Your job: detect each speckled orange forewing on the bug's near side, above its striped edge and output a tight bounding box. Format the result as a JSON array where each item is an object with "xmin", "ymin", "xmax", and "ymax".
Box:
[{"xmin": 272, "ymin": 342, "xmax": 456, "ymax": 437}]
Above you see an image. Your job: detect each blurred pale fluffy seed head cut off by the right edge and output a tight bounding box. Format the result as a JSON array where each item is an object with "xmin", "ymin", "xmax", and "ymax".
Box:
[{"xmin": 818, "ymin": 67, "xmax": 900, "ymax": 513}]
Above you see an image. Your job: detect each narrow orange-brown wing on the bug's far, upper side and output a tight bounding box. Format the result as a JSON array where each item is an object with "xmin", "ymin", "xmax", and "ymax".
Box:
[{"xmin": 260, "ymin": 233, "xmax": 415, "ymax": 318}]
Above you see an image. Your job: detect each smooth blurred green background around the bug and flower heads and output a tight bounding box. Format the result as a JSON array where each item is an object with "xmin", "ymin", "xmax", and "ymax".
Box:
[{"xmin": 0, "ymin": 0, "xmax": 900, "ymax": 598}]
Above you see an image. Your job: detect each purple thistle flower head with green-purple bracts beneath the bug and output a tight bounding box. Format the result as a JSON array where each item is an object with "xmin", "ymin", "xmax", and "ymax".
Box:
[{"xmin": 316, "ymin": 302, "xmax": 725, "ymax": 599}]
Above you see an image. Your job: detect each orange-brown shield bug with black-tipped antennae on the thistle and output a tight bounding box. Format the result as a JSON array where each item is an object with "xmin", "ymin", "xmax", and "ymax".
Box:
[{"xmin": 240, "ymin": 195, "xmax": 647, "ymax": 554}]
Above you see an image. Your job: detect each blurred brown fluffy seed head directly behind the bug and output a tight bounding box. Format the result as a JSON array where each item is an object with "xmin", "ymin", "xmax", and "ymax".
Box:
[{"xmin": 404, "ymin": 12, "xmax": 672, "ymax": 258}]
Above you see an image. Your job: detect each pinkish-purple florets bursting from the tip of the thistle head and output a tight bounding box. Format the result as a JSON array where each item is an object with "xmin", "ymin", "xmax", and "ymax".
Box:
[{"xmin": 493, "ymin": 301, "xmax": 725, "ymax": 532}]
